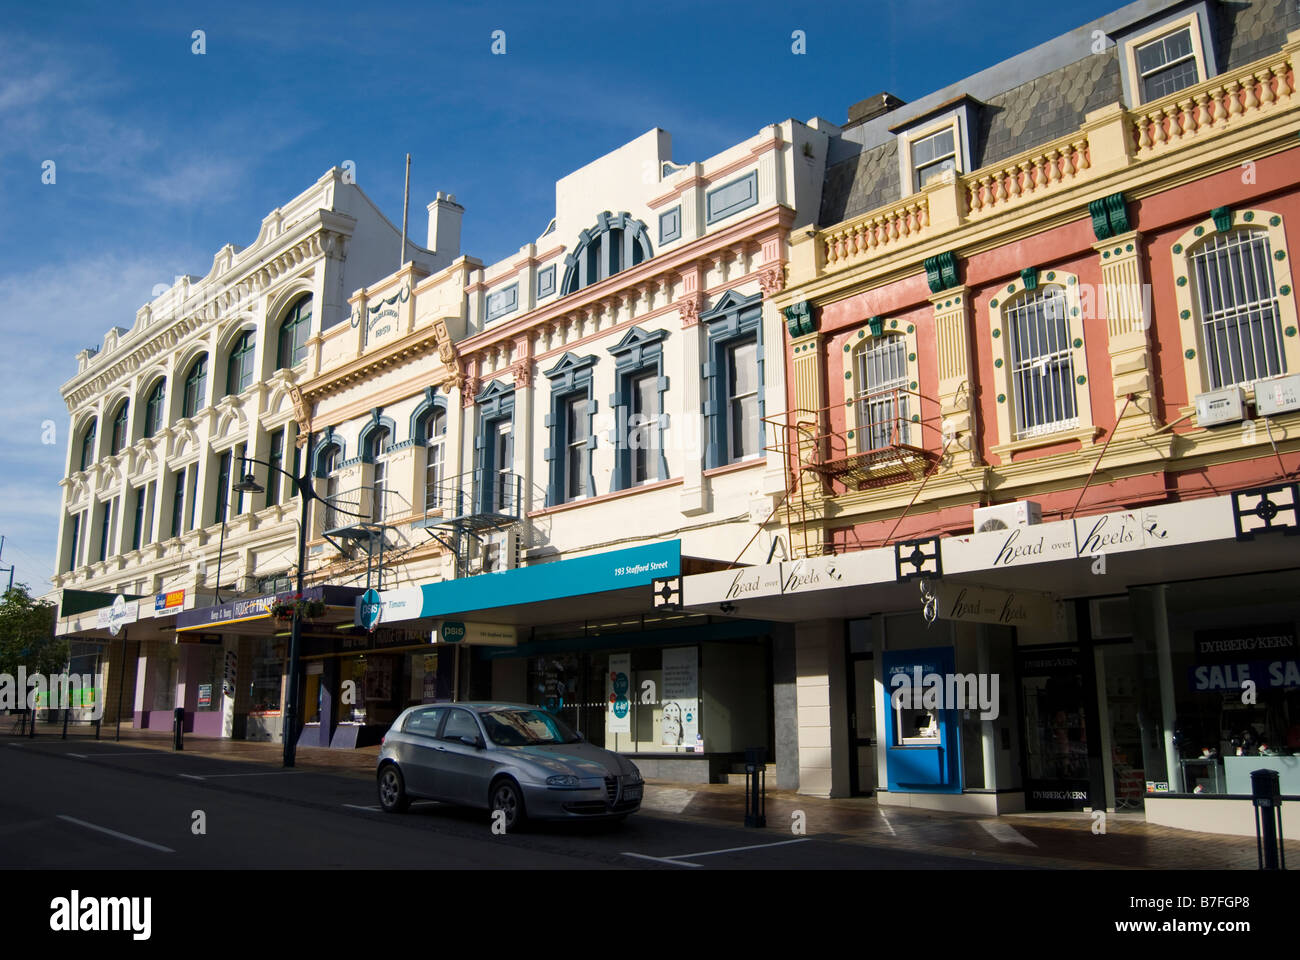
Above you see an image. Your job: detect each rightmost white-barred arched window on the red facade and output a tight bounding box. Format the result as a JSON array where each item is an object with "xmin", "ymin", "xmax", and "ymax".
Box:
[{"xmin": 1187, "ymin": 230, "xmax": 1287, "ymax": 390}]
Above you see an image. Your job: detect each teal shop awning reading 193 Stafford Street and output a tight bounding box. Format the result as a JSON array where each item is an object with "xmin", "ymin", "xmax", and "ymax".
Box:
[{"xmin": 356, "ymin": 540, "xmax": 681, "ymax": 624}]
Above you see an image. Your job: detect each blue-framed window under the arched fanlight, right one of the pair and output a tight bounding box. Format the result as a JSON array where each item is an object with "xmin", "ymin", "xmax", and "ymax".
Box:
[{"xmin": 610, "ymin": 327, "xmax": 668, "ymax": 490}]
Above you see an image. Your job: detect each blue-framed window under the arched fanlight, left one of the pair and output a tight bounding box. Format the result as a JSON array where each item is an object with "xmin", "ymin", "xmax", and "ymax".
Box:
[{"xmin": 545, "ymin": 354, "xmax": 597, "ymax": 506}]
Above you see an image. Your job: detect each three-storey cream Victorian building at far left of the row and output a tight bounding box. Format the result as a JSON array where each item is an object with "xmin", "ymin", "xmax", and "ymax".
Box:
[{"xmin": 53, "ymin": 169, "xmax": 437, "ymax": 736}]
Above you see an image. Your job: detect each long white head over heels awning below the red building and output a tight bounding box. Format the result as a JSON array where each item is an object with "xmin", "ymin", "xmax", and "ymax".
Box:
[{"xmin": 681, "ymin": 485, "xmax": 1300, "ymax": 626}]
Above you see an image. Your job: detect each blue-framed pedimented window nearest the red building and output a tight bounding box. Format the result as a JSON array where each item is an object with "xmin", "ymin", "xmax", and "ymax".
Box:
[{"xmin": 699, "ymin": 290, "xmax": 763, "ymax": 467}]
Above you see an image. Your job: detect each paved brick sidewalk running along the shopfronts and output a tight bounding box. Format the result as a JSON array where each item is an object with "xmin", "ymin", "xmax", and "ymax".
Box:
[{"xmin": 58, "ymin": 727, "xmax": 1300, "ymax": 870}]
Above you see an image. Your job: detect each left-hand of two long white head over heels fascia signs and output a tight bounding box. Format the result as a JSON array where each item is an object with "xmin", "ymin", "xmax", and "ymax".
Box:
[{"xmin": 683, "ymin": 550, "xmax": 894, "ymax": 606}]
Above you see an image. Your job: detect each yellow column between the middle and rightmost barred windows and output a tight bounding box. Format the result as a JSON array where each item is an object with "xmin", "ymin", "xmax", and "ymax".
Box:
[{"xmin": 1084, "ymin": 194, "xmax": 1158, "ymax": 440}]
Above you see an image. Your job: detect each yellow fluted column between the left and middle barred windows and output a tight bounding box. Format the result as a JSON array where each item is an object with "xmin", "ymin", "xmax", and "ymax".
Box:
[{"xmin": 926, "ymin": 251, "xmax": 980, "ymax": 470}]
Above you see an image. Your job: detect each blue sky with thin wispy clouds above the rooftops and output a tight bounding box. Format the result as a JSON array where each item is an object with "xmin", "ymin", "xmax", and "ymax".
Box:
[{"xmin": 0, "ymin": 0, "xmax": 1121, "ymax": 592}]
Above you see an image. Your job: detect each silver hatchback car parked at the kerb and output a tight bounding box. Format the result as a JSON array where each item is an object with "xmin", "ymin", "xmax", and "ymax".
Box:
[{"xmin": 377, "ymin": 704, "xmax": 644, "ymax": 831}]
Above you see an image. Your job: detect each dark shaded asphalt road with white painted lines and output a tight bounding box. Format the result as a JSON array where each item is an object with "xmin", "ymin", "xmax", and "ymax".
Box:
[{"xmin": 0, "ymin": 739, "xmax": 1013, "ymax": 872}]
